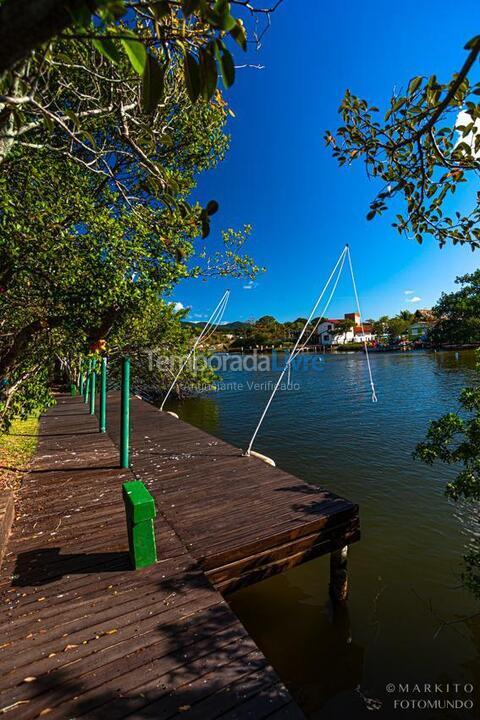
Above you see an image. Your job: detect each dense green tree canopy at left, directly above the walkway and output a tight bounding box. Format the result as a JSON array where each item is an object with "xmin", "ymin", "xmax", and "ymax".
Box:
[{"xmin": 0, "ymin": 25, "xmax": 258, "ymax": 424}]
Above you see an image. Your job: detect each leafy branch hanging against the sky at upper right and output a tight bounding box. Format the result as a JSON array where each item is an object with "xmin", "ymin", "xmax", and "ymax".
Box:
[{"xmin": 325, "ymin": 36, "xmax": 480, "ymax": 249}]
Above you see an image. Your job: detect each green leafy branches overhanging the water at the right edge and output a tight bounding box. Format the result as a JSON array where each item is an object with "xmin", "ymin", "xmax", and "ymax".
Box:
[{"xmin": 414, "ymin": 351, "xmax": 480, "ymax": 598}]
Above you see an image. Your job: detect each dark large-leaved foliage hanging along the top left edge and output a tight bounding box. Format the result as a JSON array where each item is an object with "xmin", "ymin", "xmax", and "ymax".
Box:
[{"xmin": 0, "ymin": 0, "xmax": 283, "ymax": 100}]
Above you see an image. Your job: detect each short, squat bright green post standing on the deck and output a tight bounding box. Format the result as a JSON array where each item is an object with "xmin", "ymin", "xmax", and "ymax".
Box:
[{"xmin": 122, "ymin": 480, "xmax": 157, "ymax": 570}]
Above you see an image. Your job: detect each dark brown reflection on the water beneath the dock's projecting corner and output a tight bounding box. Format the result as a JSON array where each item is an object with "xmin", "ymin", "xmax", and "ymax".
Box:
[{"xmin": 231, "ymin": 563, "xmax": 364, "ymax": 717}]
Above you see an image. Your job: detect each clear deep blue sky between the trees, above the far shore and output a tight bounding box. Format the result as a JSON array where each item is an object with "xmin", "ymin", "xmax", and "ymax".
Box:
[{"xmin": 173, "ymin": 0, "xmax": 480, "ymax": 321}]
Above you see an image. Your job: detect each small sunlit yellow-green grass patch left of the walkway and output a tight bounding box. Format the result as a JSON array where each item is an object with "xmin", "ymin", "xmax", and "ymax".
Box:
[{"xmin": 0, "ymin": 417, "xmax": 38, "ymax": 492}]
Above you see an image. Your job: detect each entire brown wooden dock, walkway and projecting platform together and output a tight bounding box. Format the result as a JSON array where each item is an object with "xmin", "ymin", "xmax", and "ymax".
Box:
[{"xmin": 0, "ymin": 394, "xmax": 359, "ymax": 720}]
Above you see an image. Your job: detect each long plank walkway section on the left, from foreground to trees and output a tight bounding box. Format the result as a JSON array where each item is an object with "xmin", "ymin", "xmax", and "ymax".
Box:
[{"xmin": 0, "ymin": 397, "xmax": 303, "ymax": 720}]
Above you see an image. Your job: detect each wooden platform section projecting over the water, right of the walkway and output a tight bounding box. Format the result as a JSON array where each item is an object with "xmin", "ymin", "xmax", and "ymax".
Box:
[{"xmin": 108, "ymin": 393, "xmax": 359, "ymax": 593}]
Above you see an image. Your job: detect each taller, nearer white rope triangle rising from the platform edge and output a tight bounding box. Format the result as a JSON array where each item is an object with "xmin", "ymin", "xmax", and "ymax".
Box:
[{"xmin": 244, "ymin": 245, "xmax": 377, "ymax": 463}]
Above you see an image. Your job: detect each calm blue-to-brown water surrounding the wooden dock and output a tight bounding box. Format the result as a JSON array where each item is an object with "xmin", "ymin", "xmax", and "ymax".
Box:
[{"xmin": 166, "ymin": 352, "xmax": 480, "ymax": 720}]
